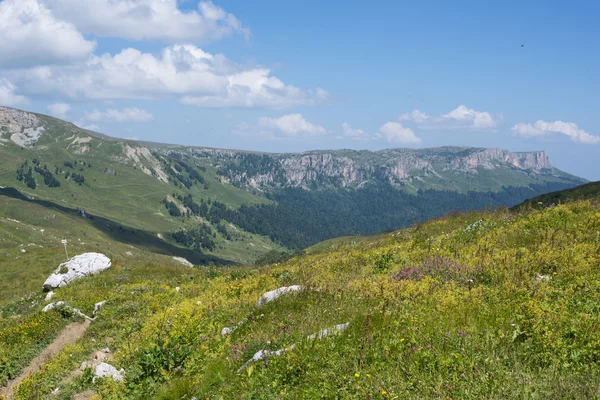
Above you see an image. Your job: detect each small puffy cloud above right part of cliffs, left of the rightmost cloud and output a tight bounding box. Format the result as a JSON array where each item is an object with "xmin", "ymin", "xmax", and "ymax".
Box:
[{"xmin": 399, "ymin": 105, "xmax": 498, "ymax": 131}]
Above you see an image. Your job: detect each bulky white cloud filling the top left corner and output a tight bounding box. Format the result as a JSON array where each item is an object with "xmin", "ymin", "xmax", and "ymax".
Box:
[{"xmin": 0, "ymin": 0, "xmax": 96, "ymax": 67}]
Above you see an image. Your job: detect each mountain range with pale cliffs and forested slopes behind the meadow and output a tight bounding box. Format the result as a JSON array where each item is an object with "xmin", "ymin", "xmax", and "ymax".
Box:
[{"xmin": 0, "ymin": 107, "xmax": 585, "ymax": 263}]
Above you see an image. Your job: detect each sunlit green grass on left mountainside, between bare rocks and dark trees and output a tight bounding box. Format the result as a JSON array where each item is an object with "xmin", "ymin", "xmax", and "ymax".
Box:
[{"xmin": 0, "ymin": 115, "xmax": 280, "ymax": 263}]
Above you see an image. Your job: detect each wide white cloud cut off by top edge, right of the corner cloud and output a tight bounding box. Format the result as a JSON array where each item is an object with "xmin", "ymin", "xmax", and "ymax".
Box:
[{"xmin": 43, "ymin": 0, "xmax": 250, "ymax": 42}]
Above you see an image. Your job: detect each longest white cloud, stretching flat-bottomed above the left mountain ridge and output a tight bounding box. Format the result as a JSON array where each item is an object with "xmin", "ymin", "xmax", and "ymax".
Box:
[{"xmin": 10, "ymin": 45, "xmax": 327, "ymax": 108}]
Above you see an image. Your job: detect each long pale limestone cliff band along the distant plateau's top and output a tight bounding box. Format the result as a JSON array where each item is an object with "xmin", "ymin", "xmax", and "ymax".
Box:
[{"xmin": 194, "ymin": 147, "xmax": 555, "ymax": 188}]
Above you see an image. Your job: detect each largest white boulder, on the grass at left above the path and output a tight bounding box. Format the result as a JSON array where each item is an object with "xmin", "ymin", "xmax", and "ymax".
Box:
[{"xmin": 44, "ymin": 253, "xmax": 112, "ymax": 291}]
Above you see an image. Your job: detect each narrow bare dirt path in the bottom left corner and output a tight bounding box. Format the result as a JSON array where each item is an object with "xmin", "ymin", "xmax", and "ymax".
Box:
[{"xmin": 0, "ymin": 319, "xmax": 90, "ymax": 399}]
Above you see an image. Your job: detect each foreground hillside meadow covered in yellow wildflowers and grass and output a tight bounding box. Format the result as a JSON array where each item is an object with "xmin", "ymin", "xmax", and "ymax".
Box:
[{"xmin": 0, "ymin": 193, "xmax": 600, "ymax": 399}]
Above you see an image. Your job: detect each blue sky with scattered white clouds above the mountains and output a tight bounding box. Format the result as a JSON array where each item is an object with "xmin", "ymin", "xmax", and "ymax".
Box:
[{"xmin": 0, "ymin": 0, "xmax": 600, "ymax": 180}]
